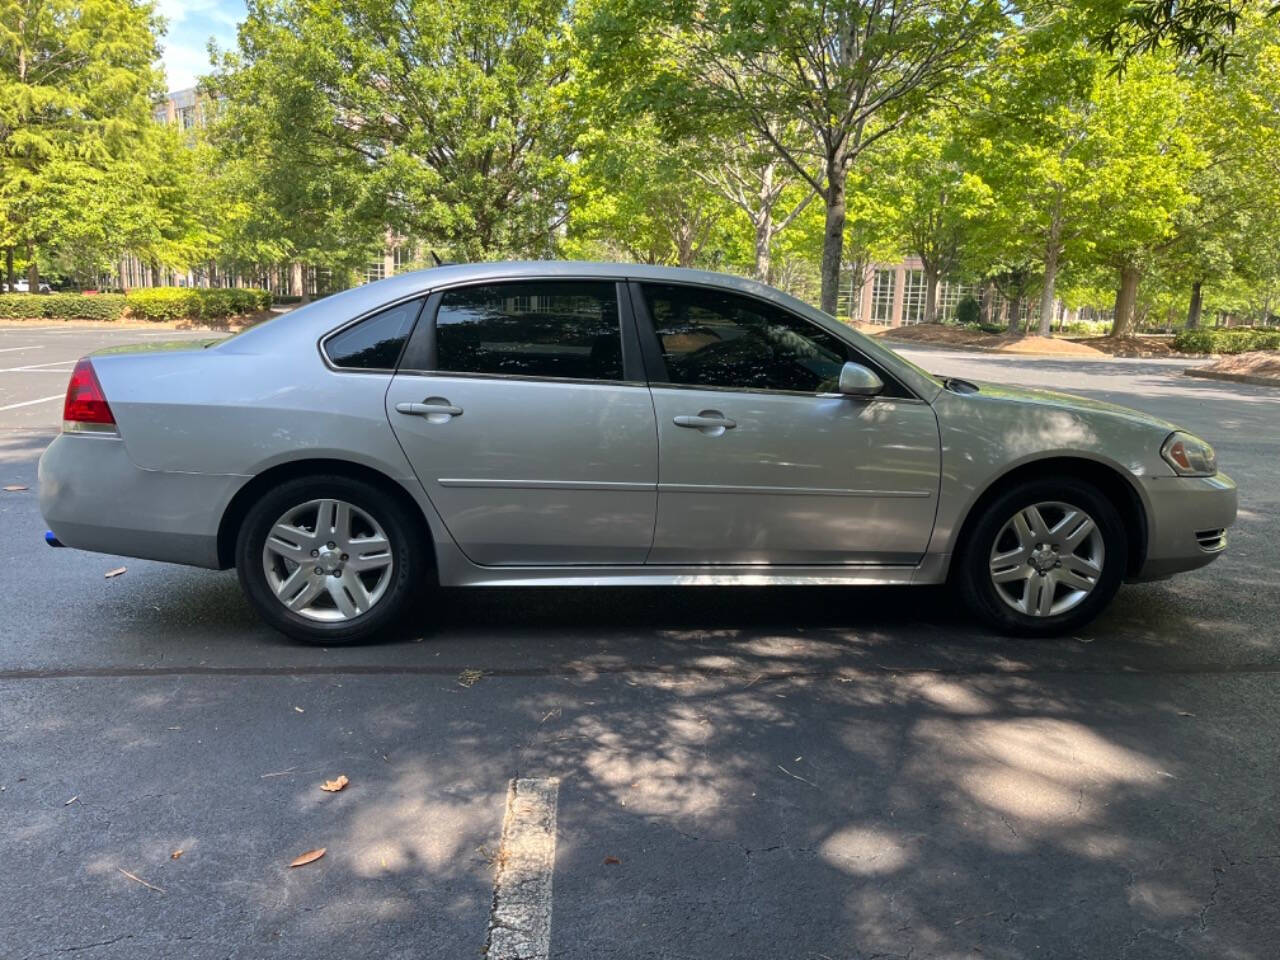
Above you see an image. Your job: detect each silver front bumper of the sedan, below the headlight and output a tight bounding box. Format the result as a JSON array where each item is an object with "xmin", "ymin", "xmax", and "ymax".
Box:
[{"xmin": 1134, "ymin": 474, "xmax": 1236, "ymax": 580}]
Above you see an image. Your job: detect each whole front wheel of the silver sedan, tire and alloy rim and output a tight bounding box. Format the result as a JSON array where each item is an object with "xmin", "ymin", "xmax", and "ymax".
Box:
[{"xmin": 956, "ymin": 477, "xmax": 1128, "ymax": 636}]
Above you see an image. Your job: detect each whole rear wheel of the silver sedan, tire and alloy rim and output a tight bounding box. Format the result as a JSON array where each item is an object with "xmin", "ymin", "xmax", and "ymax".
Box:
[{"xmin": 236, "ymin": 476, "xmax": 426, "ymax": 644}]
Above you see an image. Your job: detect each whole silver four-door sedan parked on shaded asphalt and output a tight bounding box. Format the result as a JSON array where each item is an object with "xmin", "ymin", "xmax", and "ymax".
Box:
[{"xmin": 40, "ymin": 262, "xmax": 1236, "ymax": 643}]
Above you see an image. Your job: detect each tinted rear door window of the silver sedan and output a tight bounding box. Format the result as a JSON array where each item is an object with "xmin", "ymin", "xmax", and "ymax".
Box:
[{"xmin": 435, "ymin": 280, "xmax": 623, "ymax": 380}]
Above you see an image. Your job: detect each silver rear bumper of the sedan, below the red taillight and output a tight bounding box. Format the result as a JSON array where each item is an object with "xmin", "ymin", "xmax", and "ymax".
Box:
[{"xmin": 38, "ymin": 434, "xmax": 244, "ymax": 568}]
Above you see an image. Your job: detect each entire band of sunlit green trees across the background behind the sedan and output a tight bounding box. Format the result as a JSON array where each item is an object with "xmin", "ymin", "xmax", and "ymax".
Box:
[{"xmin": 0, "ymin": 0, "xmax": 1280, "ymax": 334}]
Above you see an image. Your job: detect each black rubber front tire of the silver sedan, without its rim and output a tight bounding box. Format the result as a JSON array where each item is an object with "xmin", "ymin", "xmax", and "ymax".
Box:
[{"xmin": 951, "ymin": 477, "xmax": 1129, "ymax": 637}]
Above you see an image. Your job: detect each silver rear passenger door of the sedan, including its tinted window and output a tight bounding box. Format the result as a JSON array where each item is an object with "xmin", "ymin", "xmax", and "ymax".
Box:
[{"xmin": 387, "ymin": 279, "xmax": 658, "ymax": 566}]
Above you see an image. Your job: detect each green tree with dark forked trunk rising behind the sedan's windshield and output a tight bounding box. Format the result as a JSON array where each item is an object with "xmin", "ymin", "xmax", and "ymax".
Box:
[{"xmin": 590, "ymin": 0, "xmax": 1005, "ymax": 312}]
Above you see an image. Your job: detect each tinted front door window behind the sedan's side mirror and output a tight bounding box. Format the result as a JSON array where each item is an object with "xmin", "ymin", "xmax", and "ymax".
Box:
[{"xmin": 645, "ymin": 284, "xmax": 864, "ymax": 393}]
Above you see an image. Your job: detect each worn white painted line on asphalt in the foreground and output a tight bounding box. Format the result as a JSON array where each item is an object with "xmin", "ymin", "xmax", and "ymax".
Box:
[{"xmin": 484, "ymin": 777, "xmax": 559, "ymax": 960}]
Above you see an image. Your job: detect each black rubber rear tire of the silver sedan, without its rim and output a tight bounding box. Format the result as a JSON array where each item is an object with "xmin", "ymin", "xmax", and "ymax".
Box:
[{"xmin": 236, "ymin": 475, "xmax": 430, "ymax": 645}]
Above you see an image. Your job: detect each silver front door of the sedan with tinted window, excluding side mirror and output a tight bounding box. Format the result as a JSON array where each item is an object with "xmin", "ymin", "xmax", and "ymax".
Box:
[{"xmin": 632, "ymin": 283, "xmax": 941, "ymax": 564}]
